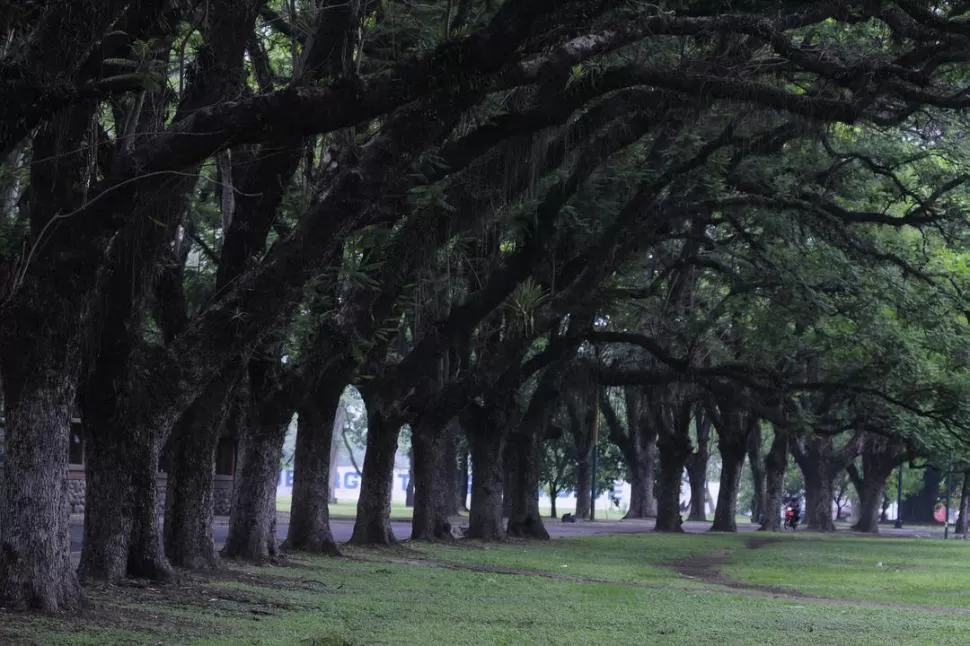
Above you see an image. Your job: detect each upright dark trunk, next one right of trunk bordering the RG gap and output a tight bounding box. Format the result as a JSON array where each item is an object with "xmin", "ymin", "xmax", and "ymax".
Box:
[{"xmin": 411, "ymin": 423, "xmax": 454, "ymax": 540}]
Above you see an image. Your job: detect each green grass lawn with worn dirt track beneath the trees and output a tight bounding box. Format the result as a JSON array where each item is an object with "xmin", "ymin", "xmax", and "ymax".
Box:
[{"xmin": 0, "ymin": 533, "xmax": 970, "ymax": 646}]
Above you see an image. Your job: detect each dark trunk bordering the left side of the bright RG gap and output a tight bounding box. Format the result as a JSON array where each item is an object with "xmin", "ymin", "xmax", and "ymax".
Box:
[{"xmin": 283, "ymin": 383, "xmax": 344, "ymax": 555}]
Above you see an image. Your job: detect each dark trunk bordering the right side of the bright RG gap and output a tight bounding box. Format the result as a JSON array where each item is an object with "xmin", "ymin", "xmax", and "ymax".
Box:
[{"xmin": 350, "ymin": 400, "xmax": 398, "ymax": 545}]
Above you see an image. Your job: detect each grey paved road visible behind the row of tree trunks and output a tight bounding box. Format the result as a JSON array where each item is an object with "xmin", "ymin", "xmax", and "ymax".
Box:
[{"xmin": 71, "ymin": 515, "xmax": 952, "ymax": 552}]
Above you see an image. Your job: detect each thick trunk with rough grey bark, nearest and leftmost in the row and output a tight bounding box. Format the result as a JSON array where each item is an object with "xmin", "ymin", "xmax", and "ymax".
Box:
[{"xmin": 0, "ymin": 374, "xmax": 82, "ymax": 612}]
